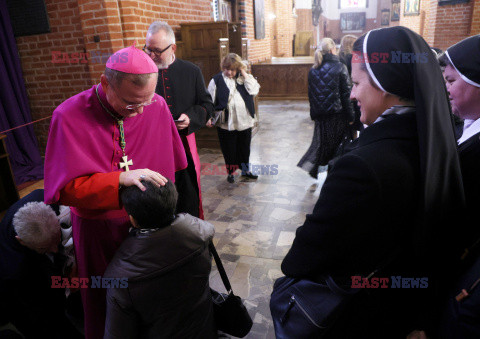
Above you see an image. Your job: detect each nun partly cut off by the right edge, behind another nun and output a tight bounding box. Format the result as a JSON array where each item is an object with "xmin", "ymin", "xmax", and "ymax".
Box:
[{"xmin": 438, "ymin": 35, "xmax": 480, "ymax": 338}]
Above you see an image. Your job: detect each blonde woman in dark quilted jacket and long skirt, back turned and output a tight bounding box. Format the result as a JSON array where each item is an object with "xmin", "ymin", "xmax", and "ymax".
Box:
[{"xmin": 297, "ymin": 38, "xmax": 354, "ymax": 178}]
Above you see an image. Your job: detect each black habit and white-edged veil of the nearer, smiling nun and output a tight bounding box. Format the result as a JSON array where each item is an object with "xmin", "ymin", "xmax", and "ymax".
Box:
[{"xmin": 282, "ymin": 26, "xmax": 464, "ymax": 338}]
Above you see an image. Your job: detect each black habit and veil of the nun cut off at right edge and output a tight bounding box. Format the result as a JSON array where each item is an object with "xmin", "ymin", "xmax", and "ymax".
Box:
[{"xmin": 439, "ymin": 35, "xmax": 480, "ymax": 338}]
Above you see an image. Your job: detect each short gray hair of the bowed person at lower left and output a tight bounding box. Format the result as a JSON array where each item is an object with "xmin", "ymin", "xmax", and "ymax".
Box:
[{"xmin": 13, "ymin": 202, "xmax": 60, "ymax": 245}]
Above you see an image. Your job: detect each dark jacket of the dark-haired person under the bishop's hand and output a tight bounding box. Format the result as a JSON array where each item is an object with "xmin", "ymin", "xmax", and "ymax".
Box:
[{"xmin": 104, "ymin": 214, "xmax": 216, "ymax": 339}]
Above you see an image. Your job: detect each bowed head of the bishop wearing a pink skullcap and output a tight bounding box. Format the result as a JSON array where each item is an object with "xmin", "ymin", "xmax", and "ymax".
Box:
[{"xmin": 100, "ymin": 45, "xmax": 158, "ymax": 117}]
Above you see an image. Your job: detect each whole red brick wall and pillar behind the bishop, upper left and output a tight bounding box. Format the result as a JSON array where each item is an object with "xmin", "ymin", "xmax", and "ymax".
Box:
[{"xmin": 16, "ymin": 0, "xmax": 213, "ymax": 154}]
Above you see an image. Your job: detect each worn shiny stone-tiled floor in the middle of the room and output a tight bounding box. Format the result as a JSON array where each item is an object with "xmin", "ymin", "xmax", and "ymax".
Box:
[{"xmin": 204, "ymin": 101, "xmax": 325, "ymax": 339}]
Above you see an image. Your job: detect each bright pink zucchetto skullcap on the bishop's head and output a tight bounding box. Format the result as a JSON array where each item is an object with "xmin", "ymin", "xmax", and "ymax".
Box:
[{"xmin": 106, "ymin": 43, "xmax": 158, "ymax": 74}]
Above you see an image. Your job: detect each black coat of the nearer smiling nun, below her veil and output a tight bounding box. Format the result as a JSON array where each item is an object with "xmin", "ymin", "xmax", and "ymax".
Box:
[{"xmin": 282, "ymin": 113, "xmax": 448, "ymax": 338}]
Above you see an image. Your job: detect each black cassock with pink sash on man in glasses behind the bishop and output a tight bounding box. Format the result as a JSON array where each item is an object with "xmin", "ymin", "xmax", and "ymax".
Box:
[{"xmin": 155, "ymin": 59, "xmax": 213, "ymax": 218}]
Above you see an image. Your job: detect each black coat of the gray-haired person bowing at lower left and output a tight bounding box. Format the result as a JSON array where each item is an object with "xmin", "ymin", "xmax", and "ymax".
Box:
[{"xmin": 0, "ymin": 190, "xmax": 80, "ymax": 338}]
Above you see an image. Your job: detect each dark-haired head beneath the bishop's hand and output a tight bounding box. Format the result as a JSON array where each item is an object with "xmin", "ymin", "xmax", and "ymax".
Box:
[{"xmin": 121, "ymin": 180, "xmax": 178, "ymax": 228}]
